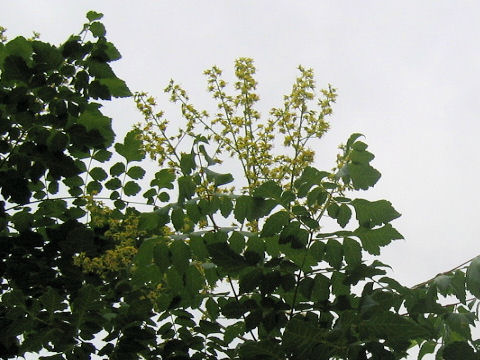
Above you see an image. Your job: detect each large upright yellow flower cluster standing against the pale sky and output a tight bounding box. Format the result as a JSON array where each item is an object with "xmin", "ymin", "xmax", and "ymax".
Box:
[{"xmin": 135, "ymin": 58, "xmax": 336, "ymax": 192}]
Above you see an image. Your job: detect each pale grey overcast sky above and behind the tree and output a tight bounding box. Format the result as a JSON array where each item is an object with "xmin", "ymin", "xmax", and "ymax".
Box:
[{"xmin": 0, "ymin": 0, "xmax": 480, "ymax": 354}]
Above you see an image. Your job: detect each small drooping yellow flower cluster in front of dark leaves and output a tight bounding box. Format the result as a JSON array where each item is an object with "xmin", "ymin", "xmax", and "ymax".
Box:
[{"xmin": 74, "ymin": 196, "xmax": 144, "ymax": 275}]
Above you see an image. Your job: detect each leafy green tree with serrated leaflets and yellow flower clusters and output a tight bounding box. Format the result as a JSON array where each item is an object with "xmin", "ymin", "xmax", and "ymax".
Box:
[{"xmin": 0, "ymin": 11, "xmax": 480, "ymax": 360}]
